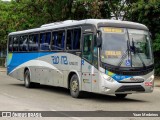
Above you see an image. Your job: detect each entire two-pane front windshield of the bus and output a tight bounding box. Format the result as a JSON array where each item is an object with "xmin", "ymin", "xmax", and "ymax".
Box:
[{"xmin": 101, "ymin": 27, "xmax": 153, "ymax": 67}]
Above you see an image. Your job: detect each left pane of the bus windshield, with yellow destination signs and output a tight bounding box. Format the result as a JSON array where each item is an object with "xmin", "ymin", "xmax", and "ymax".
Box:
[{"xmin": 101, "ymin": 27, "xmax": 130, "ymax": 67}]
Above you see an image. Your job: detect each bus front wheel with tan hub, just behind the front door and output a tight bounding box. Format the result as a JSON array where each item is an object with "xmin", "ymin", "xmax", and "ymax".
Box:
[{"xmin": 70, "ymin": 74, "xmax": 82, "ymax": 98}]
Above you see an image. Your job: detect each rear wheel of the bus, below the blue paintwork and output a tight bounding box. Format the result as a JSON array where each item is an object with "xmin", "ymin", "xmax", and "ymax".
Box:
[{"xmin": 24, "ymin": 70, "xmax": 34, "ymax": 88}]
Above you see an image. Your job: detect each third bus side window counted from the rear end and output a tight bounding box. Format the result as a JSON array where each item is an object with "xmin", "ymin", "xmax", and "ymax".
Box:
[{"xmin": 19, "ymin": 35, "xmax": 28, "ymax": 51}]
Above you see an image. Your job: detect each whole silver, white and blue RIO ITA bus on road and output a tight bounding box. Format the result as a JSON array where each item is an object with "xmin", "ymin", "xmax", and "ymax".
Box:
[{"xmin": 7, "ymin": 19, "xmax": 154, "ymax": 98}]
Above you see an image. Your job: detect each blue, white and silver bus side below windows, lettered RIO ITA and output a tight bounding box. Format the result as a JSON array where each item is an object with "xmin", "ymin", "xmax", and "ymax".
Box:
[{"xmin": 8, "ymin": 52, "xmax": 81, "ymax": 88}]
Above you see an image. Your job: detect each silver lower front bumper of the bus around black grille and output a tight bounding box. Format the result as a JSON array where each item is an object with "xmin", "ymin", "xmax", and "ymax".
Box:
[{"xmin": 100, "ymin": 75, "xmax": 154, "ymax": 94}]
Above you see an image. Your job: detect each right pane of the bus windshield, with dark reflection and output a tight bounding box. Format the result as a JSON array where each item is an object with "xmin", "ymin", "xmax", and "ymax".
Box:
[{"xmin": 128, "ymin": 29, "xmax": 153, "ymax": 67}]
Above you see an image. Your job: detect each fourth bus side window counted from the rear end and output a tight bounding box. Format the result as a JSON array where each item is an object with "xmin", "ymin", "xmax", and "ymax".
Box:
[{"xmin": 28, "ymin": 34, "xmax": 39, "ymax": 51}]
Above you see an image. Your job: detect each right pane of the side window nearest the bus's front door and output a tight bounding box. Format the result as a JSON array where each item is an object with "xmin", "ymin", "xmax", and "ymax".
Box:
[{"xmin": 73, "ymin": 29, "xmax": 81, "ymax": 50}]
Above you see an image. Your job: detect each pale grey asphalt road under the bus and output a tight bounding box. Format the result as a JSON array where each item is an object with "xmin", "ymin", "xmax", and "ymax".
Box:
[{"xmin": 0, "ymin": 71, "xmax": 160, "ymax": 120}]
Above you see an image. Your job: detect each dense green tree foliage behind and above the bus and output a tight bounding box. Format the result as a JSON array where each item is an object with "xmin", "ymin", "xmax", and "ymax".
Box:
[{"xmin": 0, "ymin": 0, "xmax": 160, "ymax": 74}]
